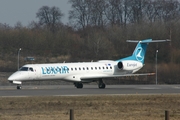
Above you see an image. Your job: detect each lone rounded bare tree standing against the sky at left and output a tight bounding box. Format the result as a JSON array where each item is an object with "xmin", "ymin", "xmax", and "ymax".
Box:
[{"xmin": 36, "ymin": 6, "xmax": 64, "ymax": 32}]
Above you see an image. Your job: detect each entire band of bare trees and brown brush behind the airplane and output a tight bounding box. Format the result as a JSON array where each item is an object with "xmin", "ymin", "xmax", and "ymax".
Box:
[{"xmin": 0, "ymin": 0, "xmax": 180, "ymax": 83}]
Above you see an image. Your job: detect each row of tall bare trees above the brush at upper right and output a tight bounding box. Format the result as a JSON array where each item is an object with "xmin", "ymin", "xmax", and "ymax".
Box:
[{"xmin": 69, "ymin": 0, "xmax": 180, "ymax": 29}]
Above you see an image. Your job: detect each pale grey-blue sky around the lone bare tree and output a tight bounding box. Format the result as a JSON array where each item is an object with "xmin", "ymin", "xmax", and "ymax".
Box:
[{"xmin": 0, "ymin": 0, "xmax": 71, "ymax": 27}]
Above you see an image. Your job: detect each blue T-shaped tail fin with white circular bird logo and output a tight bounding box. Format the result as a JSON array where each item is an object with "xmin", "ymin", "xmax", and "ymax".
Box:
[{"xmin": 117, "ymin": 39, "xmax": 170, "ymax": 64}]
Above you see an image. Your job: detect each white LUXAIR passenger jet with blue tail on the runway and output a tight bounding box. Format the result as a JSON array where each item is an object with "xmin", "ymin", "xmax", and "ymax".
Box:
[{"xmin": 8, "ymin": 39, "xmax": 170, "ymax": 89}]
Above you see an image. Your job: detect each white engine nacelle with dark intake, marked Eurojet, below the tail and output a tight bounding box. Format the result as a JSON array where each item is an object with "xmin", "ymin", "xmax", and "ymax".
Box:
[{"xmin": 117, "ymin": 60, "xmax": 143, "ymax": 71}]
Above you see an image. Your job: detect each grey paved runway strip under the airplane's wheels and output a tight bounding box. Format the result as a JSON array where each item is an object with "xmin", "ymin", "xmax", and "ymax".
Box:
[{"xmin": 0, "ymin": 84, "xmax": 180, "ymax": 97}]
